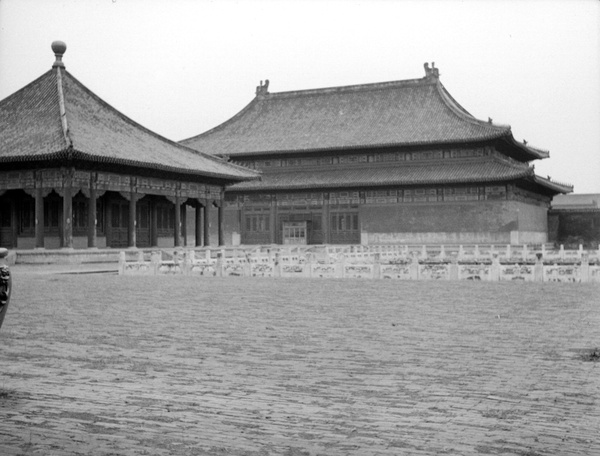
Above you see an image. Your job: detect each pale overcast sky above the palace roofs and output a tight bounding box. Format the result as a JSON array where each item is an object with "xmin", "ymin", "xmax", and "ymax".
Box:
[{"xmin": 0, "ymin": 0, "xmax": 600, "ymax": 193}]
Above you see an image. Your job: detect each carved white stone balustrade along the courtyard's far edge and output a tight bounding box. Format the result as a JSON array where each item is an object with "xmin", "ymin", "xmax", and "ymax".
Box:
[{"xmin": 119, "ymin": 246, "xmax": 600, "ymax": 283}]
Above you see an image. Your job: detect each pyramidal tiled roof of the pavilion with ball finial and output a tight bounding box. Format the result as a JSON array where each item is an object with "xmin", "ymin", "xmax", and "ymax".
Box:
[{"xmin": 0, "ymin": 69, "xmax": 256, "ymax": 181}]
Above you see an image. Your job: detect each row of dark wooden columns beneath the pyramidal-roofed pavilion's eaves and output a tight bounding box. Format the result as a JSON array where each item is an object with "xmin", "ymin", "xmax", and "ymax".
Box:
[{"xmin": 35, "ymin": 186, "xmax": 225, "ymax": 248}]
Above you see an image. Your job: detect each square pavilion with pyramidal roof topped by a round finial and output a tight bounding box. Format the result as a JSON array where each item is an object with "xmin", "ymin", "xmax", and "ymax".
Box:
[{"xmin": 0, "ymin": 42, "xmax": 258, "ymax": 249}]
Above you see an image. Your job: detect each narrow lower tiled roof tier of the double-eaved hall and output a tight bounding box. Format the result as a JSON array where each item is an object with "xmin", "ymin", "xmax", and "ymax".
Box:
[{"xmin": 231, "ymin": 160, "xmax": 533, "ymax": 191}]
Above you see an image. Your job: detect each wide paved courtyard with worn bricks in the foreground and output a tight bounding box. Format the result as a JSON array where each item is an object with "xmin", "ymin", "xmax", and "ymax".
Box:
[{"xmin": 0, "ymin": 266, "xmax": 600, "ymax": 456}]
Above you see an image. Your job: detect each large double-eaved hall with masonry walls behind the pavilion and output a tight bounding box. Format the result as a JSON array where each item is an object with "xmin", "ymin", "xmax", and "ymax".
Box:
[{"xmin": 181, "ymin": 64, "xmax": 572, "ymax": 244}]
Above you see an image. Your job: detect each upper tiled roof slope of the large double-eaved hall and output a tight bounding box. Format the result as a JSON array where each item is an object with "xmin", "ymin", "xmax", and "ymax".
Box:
[{"xmin": 182, "ymin": 78, "xmax": 512, "ymax": 156}]
